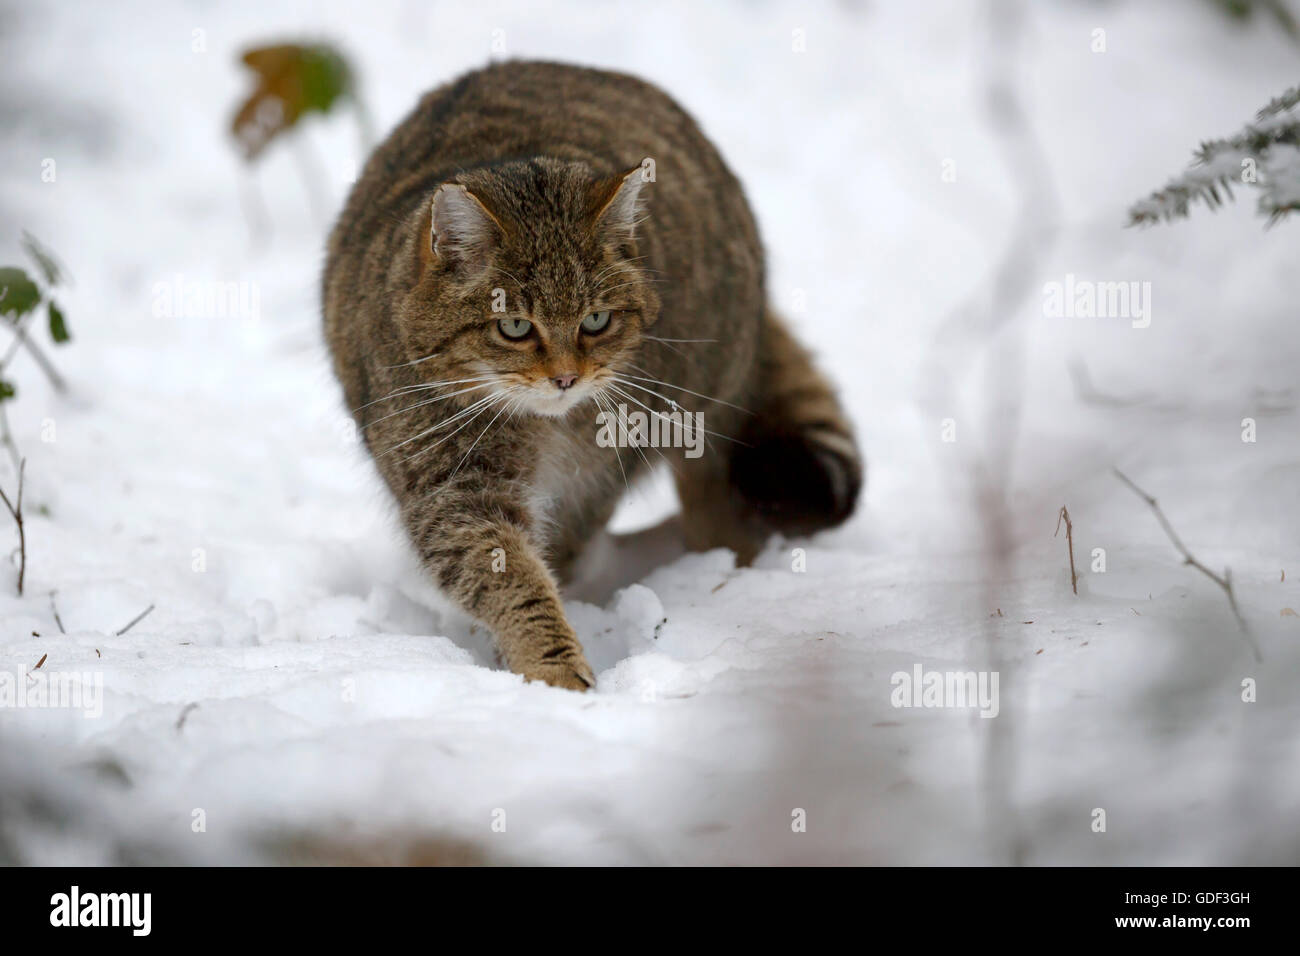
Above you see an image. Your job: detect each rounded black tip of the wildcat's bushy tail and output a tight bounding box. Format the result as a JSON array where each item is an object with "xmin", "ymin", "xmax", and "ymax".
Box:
[{"xmin": 731, "ymin": 434, "xmax": 862, "ymax": 535}]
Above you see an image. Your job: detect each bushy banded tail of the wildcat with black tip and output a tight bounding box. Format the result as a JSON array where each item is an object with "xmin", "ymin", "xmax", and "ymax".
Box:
[{"xmin": 731, "ymin": 308, "xmax": 866, "ymax": 535}]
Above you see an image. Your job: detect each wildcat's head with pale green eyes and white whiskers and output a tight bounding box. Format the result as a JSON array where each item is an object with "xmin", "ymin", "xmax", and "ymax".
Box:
[{"xmin": 403, "ymin": 159, "xmax": 659, "ymax": 416}]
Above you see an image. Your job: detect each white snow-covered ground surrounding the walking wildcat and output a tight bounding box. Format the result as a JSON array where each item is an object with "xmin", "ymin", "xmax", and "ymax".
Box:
[{"xmin": 0, "ymin": 0, "xmax": 1300, "ymax": 864}]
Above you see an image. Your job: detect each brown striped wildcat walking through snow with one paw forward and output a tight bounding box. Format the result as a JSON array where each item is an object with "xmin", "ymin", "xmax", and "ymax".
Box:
[{"xmin": 322, "ymin": 61, "xmax": 863, "ymax": 691}]
